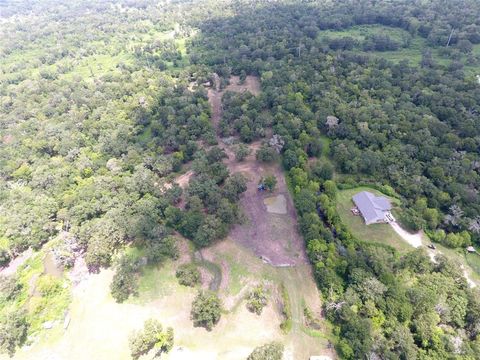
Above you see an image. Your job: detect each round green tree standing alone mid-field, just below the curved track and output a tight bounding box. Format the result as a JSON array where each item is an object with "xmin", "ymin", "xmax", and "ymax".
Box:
[{"xmin": 190, "ymin": 291, "xmax": 222, "ymax": 331}]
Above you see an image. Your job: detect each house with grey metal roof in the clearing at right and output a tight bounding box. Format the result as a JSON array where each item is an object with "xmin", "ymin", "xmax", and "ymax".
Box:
[{"xmin": 352, "ymin": 191, "xmax": 393, "ymax": 225}]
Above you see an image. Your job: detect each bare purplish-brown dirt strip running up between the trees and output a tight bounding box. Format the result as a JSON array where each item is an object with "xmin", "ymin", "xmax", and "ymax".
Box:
[{"xmin": 204, "ymin": 76, "xmax": 307, "ymax": 266}]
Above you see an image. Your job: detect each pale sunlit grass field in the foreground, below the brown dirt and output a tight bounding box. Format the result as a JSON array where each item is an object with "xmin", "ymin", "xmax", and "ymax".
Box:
[{"xmin": 4, "ymin": 239, "xmax": 328, "ymax": 360}]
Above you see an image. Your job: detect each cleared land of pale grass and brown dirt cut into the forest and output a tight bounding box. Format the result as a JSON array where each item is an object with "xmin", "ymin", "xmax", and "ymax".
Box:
[{"xmin": 4, "ymin": 74, "xmax": 335, "ymax": 360}]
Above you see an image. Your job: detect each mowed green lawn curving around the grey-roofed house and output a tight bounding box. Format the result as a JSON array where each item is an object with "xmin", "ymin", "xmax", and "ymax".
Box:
[{"xmin": 337, "ymin": 187, "xmax": 412, "ymax": 251}]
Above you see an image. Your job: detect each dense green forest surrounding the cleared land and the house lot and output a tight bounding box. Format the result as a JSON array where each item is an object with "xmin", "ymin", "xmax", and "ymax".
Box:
[{"xmin": 0, "ymin": 0, "xmax": 480, "ymax": 359}]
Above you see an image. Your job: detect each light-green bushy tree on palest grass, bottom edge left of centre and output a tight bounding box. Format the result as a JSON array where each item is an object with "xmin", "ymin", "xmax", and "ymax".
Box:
[{"xmin": 129, "ymin": 319, "xmax": 174, "ymax": 360}]
